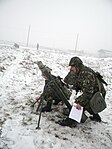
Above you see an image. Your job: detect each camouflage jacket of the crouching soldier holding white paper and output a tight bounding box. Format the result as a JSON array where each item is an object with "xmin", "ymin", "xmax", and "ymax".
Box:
[{"xmin": 65, "ymin": 65, "xmax": 106, "ymax": 108}]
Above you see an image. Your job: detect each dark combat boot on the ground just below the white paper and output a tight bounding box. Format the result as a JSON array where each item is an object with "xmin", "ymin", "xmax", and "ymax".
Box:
[{"xmin": 56, "ymin": 117, "xmax": 77, "ymax": 127}]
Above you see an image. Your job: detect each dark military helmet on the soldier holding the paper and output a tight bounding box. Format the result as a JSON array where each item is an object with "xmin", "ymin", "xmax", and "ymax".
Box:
[{"xmin": 69, "ymin": 56, "xmax": 83, "ymax": 67}]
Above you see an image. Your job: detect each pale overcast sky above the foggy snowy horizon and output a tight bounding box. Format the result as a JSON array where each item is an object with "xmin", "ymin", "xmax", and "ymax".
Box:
[{"xmin": 0, "ymin": 0, "xmax": 112, "ymax": 51}]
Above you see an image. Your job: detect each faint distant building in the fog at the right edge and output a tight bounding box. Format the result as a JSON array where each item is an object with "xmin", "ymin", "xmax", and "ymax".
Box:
[{"xmin": 98, "ymin": 49, "xmax": 112, "ymax": 58}]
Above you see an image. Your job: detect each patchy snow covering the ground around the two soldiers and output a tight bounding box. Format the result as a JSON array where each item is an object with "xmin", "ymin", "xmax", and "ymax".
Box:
[{"xmin": 0, "ymin": 44, "xmax": 112, "ymax": 149}]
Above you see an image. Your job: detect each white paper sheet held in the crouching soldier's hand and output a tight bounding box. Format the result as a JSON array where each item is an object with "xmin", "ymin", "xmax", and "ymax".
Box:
[{"xmin": 69, "ymin": 103, "xmax": 83, "ymax": 123}]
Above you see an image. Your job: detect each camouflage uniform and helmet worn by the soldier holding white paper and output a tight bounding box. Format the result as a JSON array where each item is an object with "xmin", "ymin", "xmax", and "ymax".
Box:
[{"xmin": 69, "ymin": 57, "xmax": 106, "ymax": 114}]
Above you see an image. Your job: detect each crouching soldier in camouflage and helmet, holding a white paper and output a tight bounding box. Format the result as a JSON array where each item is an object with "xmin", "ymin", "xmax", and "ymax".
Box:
[{"xmin": 58, "ymin": 57, "xmax": 106, "ymax": 126}]
